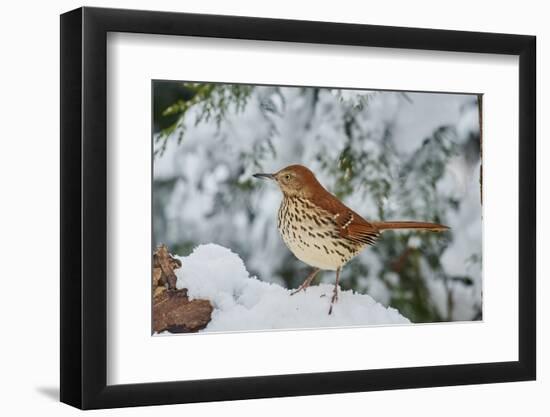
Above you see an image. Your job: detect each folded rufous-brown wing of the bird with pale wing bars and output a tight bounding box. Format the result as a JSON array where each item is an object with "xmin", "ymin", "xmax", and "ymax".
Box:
[{"xmin": 308, "ymin": 194, "xmax": 380, "ymax": 245}]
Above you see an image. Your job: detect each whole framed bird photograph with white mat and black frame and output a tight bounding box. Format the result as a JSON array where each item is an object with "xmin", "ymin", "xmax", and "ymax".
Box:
[{"xmin": 61, "ymin": 7, "xmax": 536, "ymax": 409}]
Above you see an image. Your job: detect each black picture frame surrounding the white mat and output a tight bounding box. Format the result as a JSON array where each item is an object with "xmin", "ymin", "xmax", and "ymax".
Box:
[{"xmin": 60, "ymin": 7, "xmax": 536, "ymax": 409}]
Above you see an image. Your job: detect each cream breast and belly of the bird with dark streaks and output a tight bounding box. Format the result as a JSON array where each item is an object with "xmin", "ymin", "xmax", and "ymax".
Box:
[{"xmin": 277, "ymin": 197, "xmax": 364, "ymax": 270}]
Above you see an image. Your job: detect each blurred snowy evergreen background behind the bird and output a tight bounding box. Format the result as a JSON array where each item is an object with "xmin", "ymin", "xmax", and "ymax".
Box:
[{"xmin": 153, "ymin": 81, "xmax": 482, "ymax": 322}]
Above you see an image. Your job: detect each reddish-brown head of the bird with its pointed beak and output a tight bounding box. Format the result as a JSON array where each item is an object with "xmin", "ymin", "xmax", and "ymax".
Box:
[{"xmin": 253, "ymin": 165, "xmax": 322, "ymax": 198}]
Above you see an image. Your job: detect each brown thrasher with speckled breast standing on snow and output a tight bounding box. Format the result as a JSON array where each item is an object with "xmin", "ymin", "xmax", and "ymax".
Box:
[{"xmin": 254, "ymin": 165, "xmax": 448, "ymax": 314}]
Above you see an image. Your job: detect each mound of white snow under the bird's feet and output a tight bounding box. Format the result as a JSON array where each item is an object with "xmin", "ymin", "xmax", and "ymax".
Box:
[{"xmin": 176, "ymin": 244, "xmax": 410, "ymax": 332}]
